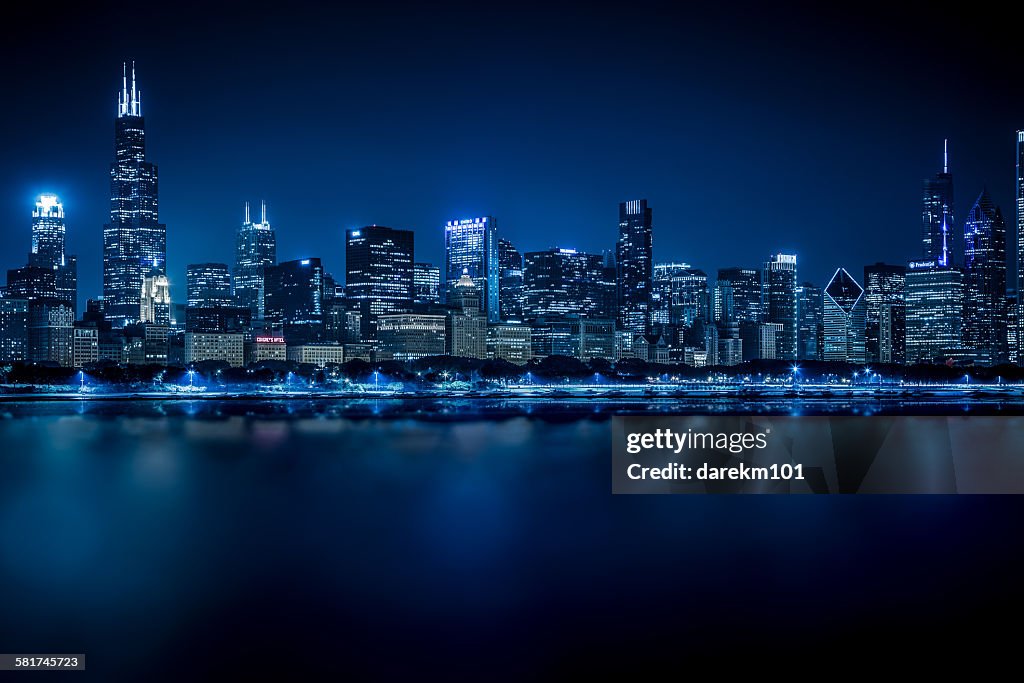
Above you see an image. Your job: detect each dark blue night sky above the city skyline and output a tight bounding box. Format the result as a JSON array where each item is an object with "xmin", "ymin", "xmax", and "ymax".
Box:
[{"xmin": 0, "ymin": 2, "xmax": 1024, "ymax": 309}]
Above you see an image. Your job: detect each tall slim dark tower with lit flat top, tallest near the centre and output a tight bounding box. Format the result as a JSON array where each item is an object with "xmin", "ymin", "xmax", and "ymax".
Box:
[{"xmin": 615, "ymin": 200, "xmax": 653, "ymax": 334}]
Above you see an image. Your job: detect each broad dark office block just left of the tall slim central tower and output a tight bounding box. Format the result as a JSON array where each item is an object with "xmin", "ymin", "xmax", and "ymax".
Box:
[{"xmin": 522, "ymin": 249, "xmax": 615, "ymax": 318}]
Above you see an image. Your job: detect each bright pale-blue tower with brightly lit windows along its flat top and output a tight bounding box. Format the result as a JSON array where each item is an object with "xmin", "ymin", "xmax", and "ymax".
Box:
[{"xmin": 444, "ymin": 216, "xmax": 501, "ymax": 323}]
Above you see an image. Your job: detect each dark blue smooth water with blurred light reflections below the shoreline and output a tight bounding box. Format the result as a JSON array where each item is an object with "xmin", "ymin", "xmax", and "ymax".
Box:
[{"xmin": 0, "ymin": 401, "xmax": 1024, "ymax": 681}]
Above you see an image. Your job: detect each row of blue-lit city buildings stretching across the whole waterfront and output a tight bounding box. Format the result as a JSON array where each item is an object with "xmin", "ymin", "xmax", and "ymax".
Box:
[{"xmin": 2, "ymin": 62, "xmax": 1024, "ymax": 366}]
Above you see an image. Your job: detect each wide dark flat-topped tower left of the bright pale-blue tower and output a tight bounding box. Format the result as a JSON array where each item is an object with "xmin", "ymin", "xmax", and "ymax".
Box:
[{"xmin": 345, "ymin": 225, "xmax": 414, "ymax": 341}]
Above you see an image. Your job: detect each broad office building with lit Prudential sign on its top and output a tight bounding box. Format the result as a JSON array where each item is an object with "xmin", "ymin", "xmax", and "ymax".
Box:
[{"xmin": 904, "ymin": 261, "xmax": 964, "ymax": 365}]
